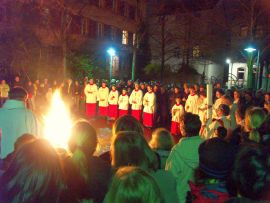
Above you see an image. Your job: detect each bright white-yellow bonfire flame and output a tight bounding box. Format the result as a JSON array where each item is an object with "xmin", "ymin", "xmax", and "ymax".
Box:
[{"xmin": 44, "ymin": 90, "xmax": 72, "ymax": 149}]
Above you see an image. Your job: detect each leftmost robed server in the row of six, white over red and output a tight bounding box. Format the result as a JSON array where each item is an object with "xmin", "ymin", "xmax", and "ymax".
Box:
[{"xmin": 84, "ymin": 79, "xmax": 98, "ymax": 118}]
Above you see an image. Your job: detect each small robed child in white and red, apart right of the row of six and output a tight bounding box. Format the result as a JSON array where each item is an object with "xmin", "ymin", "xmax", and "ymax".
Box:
[{"xmin": 171, "ymin": 97, "xmax": 184, "ymax": 136}]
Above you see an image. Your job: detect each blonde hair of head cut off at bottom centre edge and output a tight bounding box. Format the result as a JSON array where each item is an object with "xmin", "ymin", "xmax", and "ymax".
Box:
[{"xmin": 105, "ymin": 166, "xmax": 164, "ymax": 203}]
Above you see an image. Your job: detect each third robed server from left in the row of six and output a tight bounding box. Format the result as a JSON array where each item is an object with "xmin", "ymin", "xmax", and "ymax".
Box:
[{"xmin": 109, "ymin": 84, "xmax": 119, "ymax": 120}]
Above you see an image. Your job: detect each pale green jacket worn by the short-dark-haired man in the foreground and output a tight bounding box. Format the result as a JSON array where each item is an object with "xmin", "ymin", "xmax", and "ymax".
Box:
[{"xmin": 165, "ymin": 136, "xmax": 203, "ymax": 202}]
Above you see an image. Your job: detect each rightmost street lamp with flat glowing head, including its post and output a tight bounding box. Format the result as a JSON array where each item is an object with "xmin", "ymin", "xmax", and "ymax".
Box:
[{"xmin": 244, "ymin": 47, "xmax": 260, "ymax": 89}]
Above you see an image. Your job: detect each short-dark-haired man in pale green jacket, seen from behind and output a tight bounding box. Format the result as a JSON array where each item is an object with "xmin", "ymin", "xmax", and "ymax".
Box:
[{"xmin": 165, "ymin": 113, "xmax": 203, "ymax": 202}]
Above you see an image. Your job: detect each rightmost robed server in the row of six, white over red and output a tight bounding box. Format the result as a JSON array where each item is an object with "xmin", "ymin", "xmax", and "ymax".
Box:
[{"xmin": 143, "ymin": 85, "xmax": 156, "ymax": 128}]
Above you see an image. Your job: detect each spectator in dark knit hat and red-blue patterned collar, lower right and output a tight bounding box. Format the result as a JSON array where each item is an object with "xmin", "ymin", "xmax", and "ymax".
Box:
[{"xmin": 187, "ymin": 138, "xmax": 236, "ymax": 203}]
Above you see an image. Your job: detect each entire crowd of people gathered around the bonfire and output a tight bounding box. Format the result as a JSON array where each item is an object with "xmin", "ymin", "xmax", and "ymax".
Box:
[{"xmin": 0, "ymin": 77, "xmax": 270, "ymax": 203}]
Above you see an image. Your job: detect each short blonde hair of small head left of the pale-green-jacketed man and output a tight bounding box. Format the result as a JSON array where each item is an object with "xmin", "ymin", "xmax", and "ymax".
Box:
[{"xmin": 149, "ymin": 128, "xmax": 173, "ymax": 150}]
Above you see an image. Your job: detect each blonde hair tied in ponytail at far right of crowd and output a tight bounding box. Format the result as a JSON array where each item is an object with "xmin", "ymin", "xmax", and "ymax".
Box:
[{"xmin": 245, "ymin": 107, "xmax": 266, "ymax": 142}]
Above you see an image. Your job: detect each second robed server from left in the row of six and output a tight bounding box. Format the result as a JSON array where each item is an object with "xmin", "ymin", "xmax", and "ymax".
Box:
[{"xmin": 98, "ymin": 81, "xmax": 109, "ymax": 117}]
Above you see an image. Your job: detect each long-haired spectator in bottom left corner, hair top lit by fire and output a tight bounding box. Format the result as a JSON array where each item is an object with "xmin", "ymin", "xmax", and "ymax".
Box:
[{"xmin": 0, "ymin": 139, "xmax": 67, "ymax": 203}]
